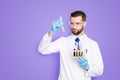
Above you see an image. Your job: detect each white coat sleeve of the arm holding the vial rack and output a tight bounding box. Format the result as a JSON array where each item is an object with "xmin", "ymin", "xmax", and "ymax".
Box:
[{"xmin": 85, "ymin": 43, "xmax": 104, "ymax": 77}]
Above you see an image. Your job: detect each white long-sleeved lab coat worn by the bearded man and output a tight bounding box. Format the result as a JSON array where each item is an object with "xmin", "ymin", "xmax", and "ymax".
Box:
[{"xmin": 38, "ymin": 33, "xmax": 103, "ymax": 80}]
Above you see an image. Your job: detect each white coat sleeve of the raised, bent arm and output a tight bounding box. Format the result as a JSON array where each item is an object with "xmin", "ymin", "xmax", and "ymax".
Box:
[{"xmin": 38, "ymin": 33, "xmax": 60, "ymax": 54}]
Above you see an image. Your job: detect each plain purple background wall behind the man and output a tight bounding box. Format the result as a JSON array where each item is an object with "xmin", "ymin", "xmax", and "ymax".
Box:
[{"xmin": 0, "ymin": 0, "xmax": 120, "ymax": 80}]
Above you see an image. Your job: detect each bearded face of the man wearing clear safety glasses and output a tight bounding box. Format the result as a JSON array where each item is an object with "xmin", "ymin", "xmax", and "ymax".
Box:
[{"xmin": 70, "ymin": 16, "xmax": 85, "ymax": 35}]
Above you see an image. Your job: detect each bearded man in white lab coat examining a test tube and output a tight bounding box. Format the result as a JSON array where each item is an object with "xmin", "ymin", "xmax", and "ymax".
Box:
[{"xmin": 38, "ymin": 11, "xmax": 103, "ymax": 80}]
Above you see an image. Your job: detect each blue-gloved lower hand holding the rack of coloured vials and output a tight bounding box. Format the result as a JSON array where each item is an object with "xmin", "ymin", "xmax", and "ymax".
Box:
[{"xmin": 77, "ymin": 56, "xmax": 89, "ymax": 70}]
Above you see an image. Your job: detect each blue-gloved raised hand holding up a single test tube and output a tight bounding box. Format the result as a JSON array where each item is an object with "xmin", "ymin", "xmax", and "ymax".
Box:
[{"xmin": 50, "ymin": 19, "xmax": 63, "ymax": 34}]
